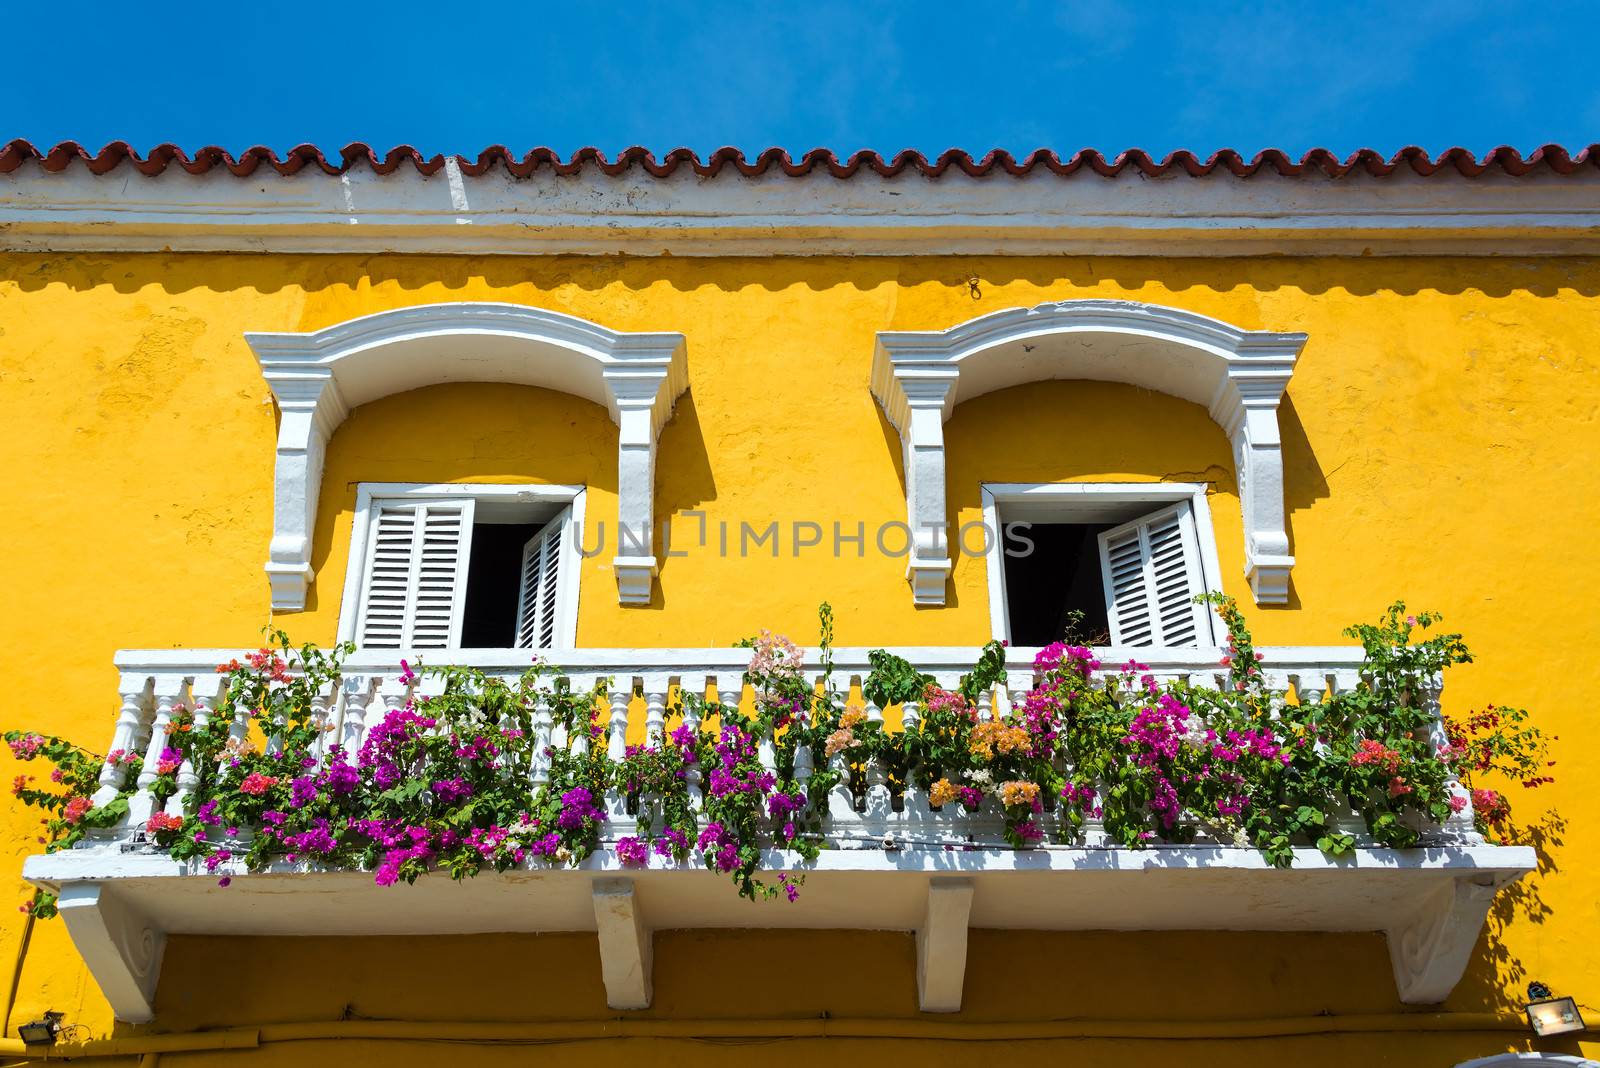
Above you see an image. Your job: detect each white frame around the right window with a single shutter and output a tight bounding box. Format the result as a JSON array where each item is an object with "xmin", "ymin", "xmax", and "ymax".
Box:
[{"xmin": 979, "ymin": 483, "xmax": 1227, "ymax": 648}]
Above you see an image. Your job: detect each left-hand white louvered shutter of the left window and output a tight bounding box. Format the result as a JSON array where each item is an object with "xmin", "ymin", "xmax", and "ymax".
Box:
[{"xmin": 357, "ymin": 499, "xmax": 474, "ymax": 649}]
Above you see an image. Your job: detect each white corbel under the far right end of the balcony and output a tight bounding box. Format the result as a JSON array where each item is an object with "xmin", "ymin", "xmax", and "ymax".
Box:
[{"xmin": 1386, "ymin": 876, "xmax": 1504, "ymax": 1006}]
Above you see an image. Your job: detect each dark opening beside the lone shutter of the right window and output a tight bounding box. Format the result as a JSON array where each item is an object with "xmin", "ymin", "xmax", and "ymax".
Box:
[{"xmin": 1002, "ymin": 523, "xmax": 1112, "ymax": 646}]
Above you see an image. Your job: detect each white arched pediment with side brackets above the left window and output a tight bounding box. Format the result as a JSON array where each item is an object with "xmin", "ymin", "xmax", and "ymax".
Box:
[{"xmin": 245, "ymin": 302, "xmax": 688, "ymax": 611}]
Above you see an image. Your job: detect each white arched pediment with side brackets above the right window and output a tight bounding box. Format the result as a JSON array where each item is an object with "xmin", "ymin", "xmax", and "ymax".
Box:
[{"xmin": 872, "ymin": 301, "xmax": 1306, "ymax": 604}]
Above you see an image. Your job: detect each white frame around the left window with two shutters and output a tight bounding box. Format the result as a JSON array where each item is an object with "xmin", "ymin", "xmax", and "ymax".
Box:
[{"xmin": 339, "ymin": 483, "xmax": 589, "ymax": 649}]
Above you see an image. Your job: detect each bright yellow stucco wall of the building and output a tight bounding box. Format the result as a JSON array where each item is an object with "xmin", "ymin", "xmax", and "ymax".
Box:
[{"xmin": 0, "ymin": 256, "xmax": 1600, "ymax": 1063}]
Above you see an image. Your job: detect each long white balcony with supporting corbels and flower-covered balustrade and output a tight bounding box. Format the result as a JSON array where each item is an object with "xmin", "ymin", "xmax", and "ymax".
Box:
[{"xmin": 24, "ymin": 648, "xmax": 1534, "ymax": 1020}]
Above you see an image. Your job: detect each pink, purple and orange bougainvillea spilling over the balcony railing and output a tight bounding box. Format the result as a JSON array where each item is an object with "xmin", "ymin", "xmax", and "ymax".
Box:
[{"xmin": 6, "ymin": 596, "xmax": 1552, "ymax": 915}]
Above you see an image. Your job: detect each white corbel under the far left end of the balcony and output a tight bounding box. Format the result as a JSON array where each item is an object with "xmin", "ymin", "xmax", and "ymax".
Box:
[{"xmin": 56, "ymin": 883, "xmax": 166, "ymax": 1023}]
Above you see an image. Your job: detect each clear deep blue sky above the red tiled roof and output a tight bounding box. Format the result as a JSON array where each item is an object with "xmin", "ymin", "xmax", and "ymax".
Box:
[{"xmin": 12, "ymin": 0, "xmax": 1600, "ymax": 155}]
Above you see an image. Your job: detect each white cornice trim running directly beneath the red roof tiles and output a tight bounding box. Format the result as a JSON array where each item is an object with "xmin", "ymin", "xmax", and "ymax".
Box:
[{"xmin": 0, "ymin": 163, "xmax": 1600, "ymax": 256}]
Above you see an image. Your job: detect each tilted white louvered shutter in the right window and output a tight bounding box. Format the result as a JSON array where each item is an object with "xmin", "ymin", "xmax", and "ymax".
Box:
[{"xmin": 1099, "ymin": 504, "xmax": 1211, "ymax": 648}]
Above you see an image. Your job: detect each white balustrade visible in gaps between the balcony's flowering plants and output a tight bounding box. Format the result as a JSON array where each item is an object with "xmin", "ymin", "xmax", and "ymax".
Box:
[{"xmin": 96, "ymin": 648, "xmax": 1477, "ymax": 847}]
